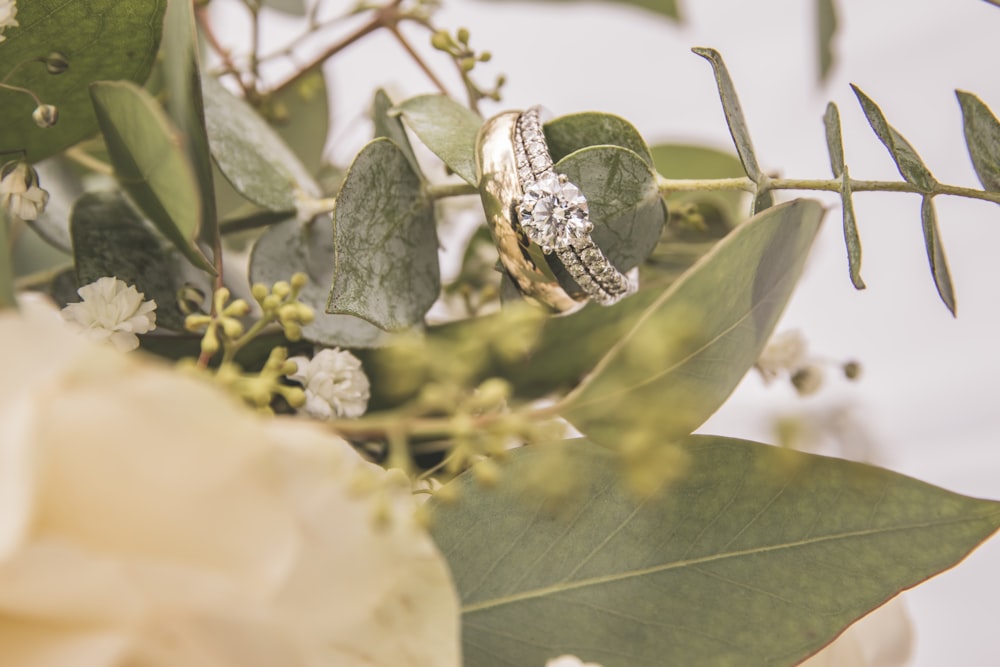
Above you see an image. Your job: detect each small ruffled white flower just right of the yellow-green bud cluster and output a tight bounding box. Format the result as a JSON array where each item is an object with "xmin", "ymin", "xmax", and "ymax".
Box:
[{"xmin": 288, "ymin": 348, "xmax": 371, "ymax": 419}]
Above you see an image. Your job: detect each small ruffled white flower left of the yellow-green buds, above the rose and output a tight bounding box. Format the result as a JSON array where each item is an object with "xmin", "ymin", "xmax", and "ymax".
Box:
[{"xmin": 62, "ymin": 277, "xmax": 156, "ymax": 352}]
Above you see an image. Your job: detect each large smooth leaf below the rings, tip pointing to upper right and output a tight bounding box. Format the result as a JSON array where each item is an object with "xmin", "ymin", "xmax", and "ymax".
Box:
[{"xmin": 560, "ymin": 200, "xmax": 823, "ymax": 445}]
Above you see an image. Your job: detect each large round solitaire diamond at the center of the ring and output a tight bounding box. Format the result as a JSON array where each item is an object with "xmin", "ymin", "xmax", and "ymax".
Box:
[{"xmin": 518, "ymin": 172, "xmax": 592, "ymax": 252}]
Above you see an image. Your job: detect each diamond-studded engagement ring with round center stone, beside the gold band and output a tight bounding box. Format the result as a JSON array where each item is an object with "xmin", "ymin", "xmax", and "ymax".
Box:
[{"xmin": 513, "ymin": 106, "xmax": 634, "ymax": 306}]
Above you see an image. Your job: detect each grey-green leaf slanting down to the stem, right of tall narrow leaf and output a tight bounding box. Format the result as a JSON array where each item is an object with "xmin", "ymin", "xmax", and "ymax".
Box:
[{"xmin": 202, "ymin": 77, "xmax": 319, "ymax": 211}]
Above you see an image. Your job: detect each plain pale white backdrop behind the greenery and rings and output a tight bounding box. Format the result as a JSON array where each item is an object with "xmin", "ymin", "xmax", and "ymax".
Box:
[{"xmin": 230, "ymin": 0, "xmax": 1000, "ymax": 667}]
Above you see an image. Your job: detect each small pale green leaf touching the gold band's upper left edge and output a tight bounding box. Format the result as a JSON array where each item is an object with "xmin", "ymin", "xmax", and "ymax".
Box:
[{"xmin": 396, "ymin": 95, "xmax": 483, "ymax": 185}]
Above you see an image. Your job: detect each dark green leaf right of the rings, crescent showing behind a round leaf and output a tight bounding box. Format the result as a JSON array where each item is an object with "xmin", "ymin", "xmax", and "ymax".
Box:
[{"xmin": 543, "ymin": 111, "xmax": 653, "ymax": 166}]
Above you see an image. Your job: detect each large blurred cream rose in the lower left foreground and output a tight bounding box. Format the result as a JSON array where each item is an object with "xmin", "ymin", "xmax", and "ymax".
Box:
[{"xmin": 0, "ymin": 298, "xmax": 460, "ymax": 667}]
